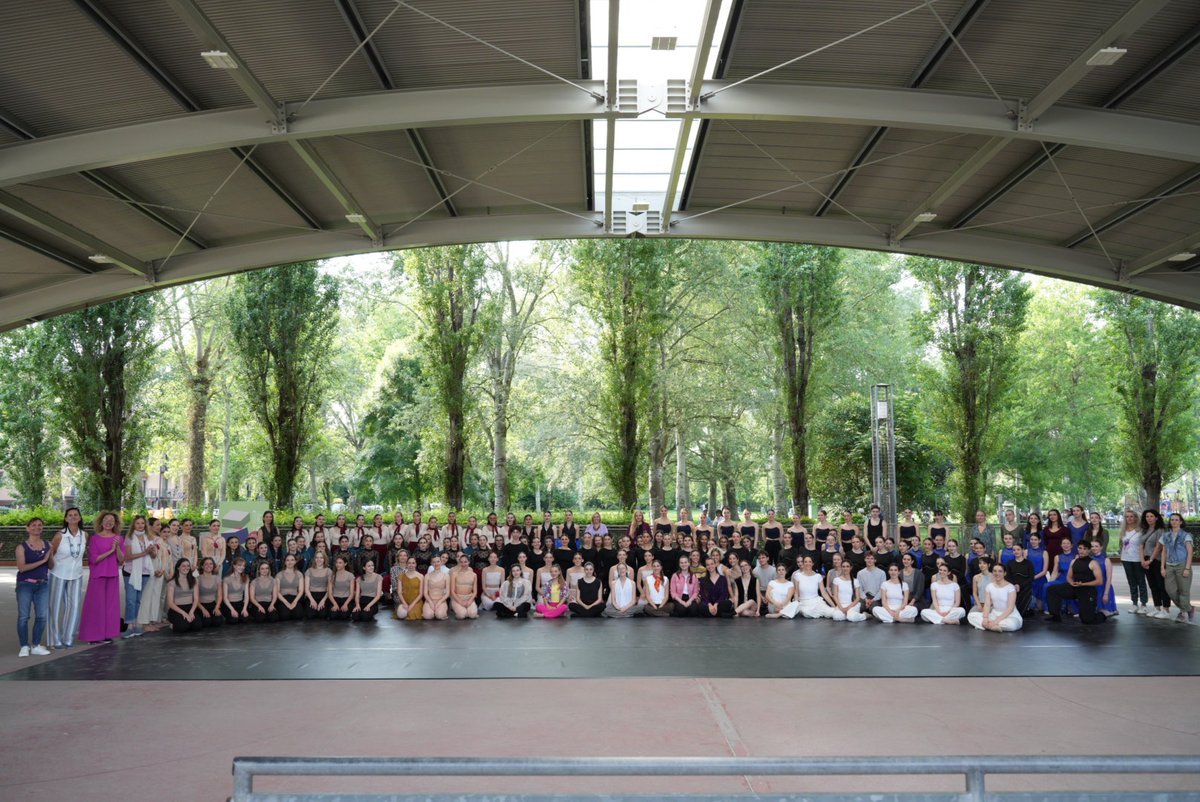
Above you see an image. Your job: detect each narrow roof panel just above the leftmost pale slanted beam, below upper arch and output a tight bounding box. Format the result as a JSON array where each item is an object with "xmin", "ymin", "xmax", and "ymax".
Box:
[{"xmin": 7, "ymin": 175, "xmax": 196, "ymax": 261}]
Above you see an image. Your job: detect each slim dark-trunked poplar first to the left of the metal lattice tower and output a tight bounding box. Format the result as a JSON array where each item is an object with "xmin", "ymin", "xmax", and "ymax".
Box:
[{"xmin": 757, "ymin": 243, "xmax": 844, "ymax": 511}]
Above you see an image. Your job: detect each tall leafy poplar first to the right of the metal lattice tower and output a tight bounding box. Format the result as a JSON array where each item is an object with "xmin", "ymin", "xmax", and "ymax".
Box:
[{"xmin": 907, "ymin": 257, "xmax": 1030, "ymax": 521}]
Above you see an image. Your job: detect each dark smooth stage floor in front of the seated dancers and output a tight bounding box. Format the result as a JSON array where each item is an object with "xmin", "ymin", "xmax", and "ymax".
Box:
[{"xmin": 0, "ymin": 610, "xmax": 1200, "ymax": 680}]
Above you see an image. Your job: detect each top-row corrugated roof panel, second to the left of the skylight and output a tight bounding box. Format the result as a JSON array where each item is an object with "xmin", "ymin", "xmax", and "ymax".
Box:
[{"xmin": 199, "ymin": 0, "xmax": 379, "ymax": 101}]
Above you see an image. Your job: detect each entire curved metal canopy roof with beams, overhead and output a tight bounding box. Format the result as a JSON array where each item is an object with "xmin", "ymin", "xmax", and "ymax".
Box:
[{"xmin": 0, "ymin": 0, "xmax": 1200, "ymax": 329}]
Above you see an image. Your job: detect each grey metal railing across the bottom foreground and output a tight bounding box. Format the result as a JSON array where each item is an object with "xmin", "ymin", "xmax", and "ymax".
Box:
[{"xmin": 230, "ymin": 755, "xmax": 1200, "ymax": 802}]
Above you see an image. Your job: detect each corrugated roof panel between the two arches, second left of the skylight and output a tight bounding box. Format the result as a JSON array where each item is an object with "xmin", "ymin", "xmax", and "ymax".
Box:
[{"xmin": 304, "ymin": 131, "xmax": 445, "ymax": 223}]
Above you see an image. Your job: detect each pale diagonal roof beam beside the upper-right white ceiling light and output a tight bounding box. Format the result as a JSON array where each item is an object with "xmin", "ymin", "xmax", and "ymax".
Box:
[{"xmin": 893, "ymin": 0, "xmax": 1170, "ymax": 241}]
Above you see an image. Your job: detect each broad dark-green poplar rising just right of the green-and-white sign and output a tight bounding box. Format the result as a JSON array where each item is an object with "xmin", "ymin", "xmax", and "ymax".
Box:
[{"xmin": 223, "ymin": 262, "xmax": 338, "ymax": 508}]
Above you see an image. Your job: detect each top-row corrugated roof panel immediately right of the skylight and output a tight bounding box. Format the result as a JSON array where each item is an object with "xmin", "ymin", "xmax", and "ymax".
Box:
[{"xmin": 725, "ymin": 0, "xmax": 964, "ymax": 86}]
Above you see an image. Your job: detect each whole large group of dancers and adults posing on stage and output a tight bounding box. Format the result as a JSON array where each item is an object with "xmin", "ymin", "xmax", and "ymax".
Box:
[{"xmin": 17, "ymin": 507, "xmax": 1193, "ymax": 656}]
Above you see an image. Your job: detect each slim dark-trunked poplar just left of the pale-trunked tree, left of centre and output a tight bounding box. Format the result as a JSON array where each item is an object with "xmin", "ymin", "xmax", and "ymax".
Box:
[{"xmin": 404, "ymin": 245, "xmax": 487, "ymax": 509}]
